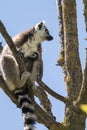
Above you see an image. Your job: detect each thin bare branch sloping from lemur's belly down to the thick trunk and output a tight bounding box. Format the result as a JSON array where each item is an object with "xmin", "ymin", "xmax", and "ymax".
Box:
[{"xmin": 37, "ymin": 81, "xmax": 67, "ymax": 103}]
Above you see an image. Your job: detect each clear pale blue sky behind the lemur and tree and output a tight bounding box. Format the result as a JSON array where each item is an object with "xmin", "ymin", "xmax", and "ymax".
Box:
[{"xmin": 0, "ymin": 0, "xmax": 87, "ymax": 130}]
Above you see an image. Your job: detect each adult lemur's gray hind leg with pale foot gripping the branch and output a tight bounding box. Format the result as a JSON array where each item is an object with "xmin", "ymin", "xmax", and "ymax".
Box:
[{"xmin": 0, "ymin": 54, "xmax": 30, "ymax": 91}]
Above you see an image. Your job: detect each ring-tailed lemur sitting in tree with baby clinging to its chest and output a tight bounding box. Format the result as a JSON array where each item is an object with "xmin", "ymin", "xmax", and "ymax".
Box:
[{"xmin": 0, "ymin": 21, "xmax": 53, "ymax": 130}]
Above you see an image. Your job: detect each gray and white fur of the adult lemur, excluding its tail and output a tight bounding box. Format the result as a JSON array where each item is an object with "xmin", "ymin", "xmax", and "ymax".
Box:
[{"xmin": 0, "ymin": 22, "xmax": 53, "ymax": 90}]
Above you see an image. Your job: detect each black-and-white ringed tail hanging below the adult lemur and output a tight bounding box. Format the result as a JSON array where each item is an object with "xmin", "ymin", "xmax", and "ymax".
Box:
[{"xmin": 15, "ymin": 89, "xmax": 37, "ymax": 130}]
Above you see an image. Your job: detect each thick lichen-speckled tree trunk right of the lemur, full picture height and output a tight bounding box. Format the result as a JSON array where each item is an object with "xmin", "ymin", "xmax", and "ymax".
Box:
[{"xmin": 57, "ymin": 0, "xmax": 86, "ymax": 130}]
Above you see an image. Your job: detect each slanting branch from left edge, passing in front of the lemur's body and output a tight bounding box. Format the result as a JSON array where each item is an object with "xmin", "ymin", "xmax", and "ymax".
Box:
[{"xmin": 0, "ymin": 21, "xmax": 34, "ymax": 100}]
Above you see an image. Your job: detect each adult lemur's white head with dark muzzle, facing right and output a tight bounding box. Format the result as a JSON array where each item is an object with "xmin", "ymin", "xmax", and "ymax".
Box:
[{"xmin": 35, "ymin": 21, "xmax": 53, "ymax": 41}]
